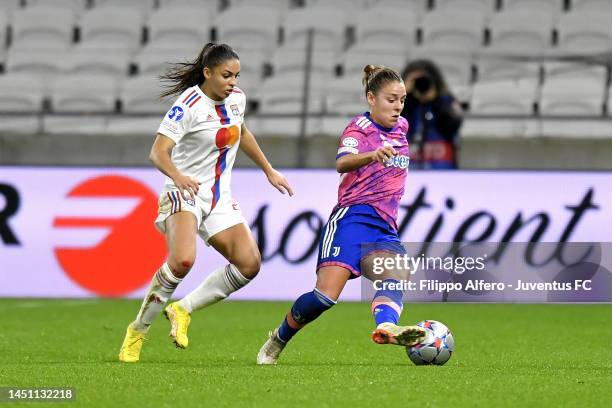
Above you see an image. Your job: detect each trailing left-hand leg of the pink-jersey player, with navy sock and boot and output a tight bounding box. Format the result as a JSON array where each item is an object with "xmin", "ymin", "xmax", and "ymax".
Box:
[{"xmin": 257, "ymin": 266, "xmax": 351, "ymax": 364}]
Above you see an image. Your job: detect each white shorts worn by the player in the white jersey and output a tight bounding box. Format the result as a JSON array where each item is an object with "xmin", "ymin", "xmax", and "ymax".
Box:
[{"xmin": 155, "ymin": 188, "xmax": 248, "ymax": 245}]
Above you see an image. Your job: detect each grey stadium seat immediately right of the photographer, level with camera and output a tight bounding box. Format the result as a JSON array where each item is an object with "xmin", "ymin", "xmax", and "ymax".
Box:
[{"xmin": 470, "ymin": 79, "xmax": 538, "ymax": 115}]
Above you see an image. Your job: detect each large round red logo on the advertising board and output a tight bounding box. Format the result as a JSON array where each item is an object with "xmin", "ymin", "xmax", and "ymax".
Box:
[{"xmin": 53, "ymin": 175, "xmax": 166, "ymax": 296}]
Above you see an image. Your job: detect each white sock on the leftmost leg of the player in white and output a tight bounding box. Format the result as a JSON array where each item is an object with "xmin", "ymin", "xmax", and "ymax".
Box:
[{"xmin": 132, "ymin": 263, "xmax": 182, "ymax": 332}]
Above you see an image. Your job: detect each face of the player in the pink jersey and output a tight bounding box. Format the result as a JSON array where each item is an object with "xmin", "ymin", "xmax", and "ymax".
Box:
[{"xmin": 368, "ymin": 81, "xmax": 406, "ymax": 128}]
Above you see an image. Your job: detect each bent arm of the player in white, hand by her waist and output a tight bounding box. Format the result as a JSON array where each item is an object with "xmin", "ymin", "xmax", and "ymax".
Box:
[{"xmin": 149, "ymin": 133, "xmax": 200, "ymax": 199}]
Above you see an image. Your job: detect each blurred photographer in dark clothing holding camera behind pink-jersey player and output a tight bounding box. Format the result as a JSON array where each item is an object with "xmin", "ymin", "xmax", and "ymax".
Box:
[{"xmin": 401, "ymin": 60, "xmax": 463, "ymax": 169}]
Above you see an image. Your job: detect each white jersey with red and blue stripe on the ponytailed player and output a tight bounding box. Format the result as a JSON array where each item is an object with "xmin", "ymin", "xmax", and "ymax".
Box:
[{"xmin": 157, "ymin": 85, "xmax": 246, "ymax": 212}]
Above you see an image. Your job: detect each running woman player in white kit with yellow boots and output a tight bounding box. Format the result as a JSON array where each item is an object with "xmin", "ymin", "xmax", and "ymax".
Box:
[{"xmin": 119, "ymin": 43, "xmax": 293, "ymax": 362}]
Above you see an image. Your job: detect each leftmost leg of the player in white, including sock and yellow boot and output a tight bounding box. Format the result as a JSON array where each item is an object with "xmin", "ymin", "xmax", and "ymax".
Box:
[{"xmin": 119, "ymin": 211, "xmax": 197, "ymax": 362}]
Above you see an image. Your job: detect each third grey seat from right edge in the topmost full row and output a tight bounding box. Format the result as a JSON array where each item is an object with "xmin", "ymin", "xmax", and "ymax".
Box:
[{"xmin": 421, "ymin": 10, "xmax": 484, "ymax": 54}]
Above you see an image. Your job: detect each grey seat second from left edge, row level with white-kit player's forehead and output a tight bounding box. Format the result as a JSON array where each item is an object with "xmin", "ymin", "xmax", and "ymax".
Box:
[{"xmin": 68, "ymin": 47, "xmax": 130, "ymax": 78}]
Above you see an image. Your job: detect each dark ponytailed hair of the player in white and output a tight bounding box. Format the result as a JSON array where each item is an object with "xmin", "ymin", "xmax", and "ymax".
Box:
[{"xmin": 159, "ymin": 43, "xmax": 239, "ymax": 98}]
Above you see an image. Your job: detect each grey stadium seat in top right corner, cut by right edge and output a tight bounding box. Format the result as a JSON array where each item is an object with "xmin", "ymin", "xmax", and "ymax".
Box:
[{"xmin": 557, "ymin": 11, "xmax": 612, "ymax": 56}]
